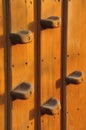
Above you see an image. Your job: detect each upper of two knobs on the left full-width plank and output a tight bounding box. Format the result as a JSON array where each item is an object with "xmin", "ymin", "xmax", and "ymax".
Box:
[{"xmin": 10, "ymin": 30, "xmax": 32, "ymax": 44}]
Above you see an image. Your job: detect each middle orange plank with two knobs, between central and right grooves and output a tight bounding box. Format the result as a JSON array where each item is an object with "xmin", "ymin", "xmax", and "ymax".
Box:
[{"xmin": 40, "ymin": 0, "xmax": 61, "ymax": 130}]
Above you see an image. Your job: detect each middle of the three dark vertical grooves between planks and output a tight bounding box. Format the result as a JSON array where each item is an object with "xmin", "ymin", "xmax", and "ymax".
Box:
[{"xmin": 34, "ymin": 0, "xmax": 41, "ymax": 130}]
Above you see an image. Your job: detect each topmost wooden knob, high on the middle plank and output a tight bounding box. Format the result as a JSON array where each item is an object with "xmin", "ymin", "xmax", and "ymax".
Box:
[{"xmin": 40, "ymin": 16, "xmax": 60, "ymax": 29}]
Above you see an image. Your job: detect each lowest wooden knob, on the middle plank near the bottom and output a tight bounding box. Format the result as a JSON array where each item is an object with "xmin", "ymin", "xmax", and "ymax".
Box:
[{"xmin": 41, "ymin": 98, "xmax": 61, "ymax": 115}]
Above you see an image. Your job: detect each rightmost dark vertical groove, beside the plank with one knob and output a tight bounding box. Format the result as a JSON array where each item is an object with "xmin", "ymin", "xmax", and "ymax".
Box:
[{"xmin": 61, "ymin": 0, "xmax": 68, "ymax": 130}]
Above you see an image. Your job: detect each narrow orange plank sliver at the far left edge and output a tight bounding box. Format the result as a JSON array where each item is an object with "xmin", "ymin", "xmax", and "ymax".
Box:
[{"xmin": 0, "ymin": 0, "xmax": 6, "ymax": 130}]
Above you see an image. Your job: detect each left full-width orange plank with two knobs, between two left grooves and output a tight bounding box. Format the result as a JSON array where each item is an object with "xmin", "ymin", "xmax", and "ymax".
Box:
[{"xmin": 10, "ymin": 0, "xmax": 36, "ymax": 130}]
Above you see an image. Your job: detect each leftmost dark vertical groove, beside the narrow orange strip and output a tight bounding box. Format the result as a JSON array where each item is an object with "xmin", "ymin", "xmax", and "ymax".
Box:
[{"xmin": 5, "ymin": 0, "xmax": 11, "ymax": 130}]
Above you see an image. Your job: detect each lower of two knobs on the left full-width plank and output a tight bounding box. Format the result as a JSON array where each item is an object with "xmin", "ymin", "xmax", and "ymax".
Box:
[{"xmin": 10, "ymin": 83, "xmax": 33, "ymax": 99}]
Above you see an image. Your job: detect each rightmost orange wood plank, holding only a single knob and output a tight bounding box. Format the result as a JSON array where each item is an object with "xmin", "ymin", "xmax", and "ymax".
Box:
[{"xmin": 66, "ymin": 0, "xmax": 86, "ymax": 130}]
